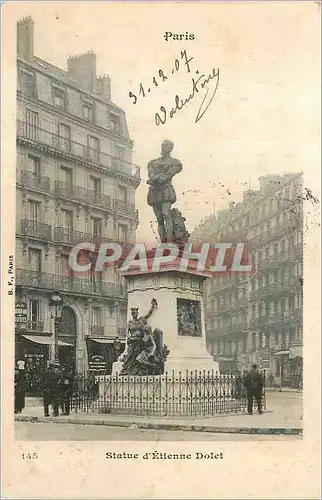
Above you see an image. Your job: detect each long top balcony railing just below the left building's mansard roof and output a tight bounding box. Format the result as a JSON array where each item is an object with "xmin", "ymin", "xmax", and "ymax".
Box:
[{"xmin": 17, "ymin": 120, "xmax": 140, "ymax": 181}]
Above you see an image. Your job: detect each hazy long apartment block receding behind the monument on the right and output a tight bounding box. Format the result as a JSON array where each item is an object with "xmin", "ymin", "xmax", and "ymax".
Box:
[{"xmin": 193, "ymin": 173, "xmax": 303, "ymax": 385}]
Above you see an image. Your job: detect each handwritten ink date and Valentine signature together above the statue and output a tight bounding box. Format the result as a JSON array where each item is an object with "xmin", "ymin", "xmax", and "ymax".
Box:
[{"xmin": 129, "ymin": 50, "xmax": 219, "ymax": 126}]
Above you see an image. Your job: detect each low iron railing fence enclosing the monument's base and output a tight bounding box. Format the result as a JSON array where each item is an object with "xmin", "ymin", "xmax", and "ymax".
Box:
[{"xmin": 71, "ymin": 371, "xmax": 266, "ymax": 417}]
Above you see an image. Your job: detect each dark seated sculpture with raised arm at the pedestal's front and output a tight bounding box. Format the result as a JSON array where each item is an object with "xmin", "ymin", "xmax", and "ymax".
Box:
[{"xmin": 120, "ymin": 299, "xmax": 169, "ymax": 375}]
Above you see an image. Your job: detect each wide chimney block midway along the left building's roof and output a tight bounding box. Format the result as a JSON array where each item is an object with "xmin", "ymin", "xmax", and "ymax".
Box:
[{"xmin": 67, "ymin": 51, "xmax": 96, "ymax": 92}]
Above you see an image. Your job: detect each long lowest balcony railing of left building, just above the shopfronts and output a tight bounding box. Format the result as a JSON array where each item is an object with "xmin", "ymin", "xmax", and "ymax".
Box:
[{"xmin": 16, "ymin": 269, "xmax": 126, "ymax": 298}]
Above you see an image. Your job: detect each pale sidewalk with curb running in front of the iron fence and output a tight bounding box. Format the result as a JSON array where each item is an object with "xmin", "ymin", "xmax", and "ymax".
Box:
[{"xmin": 15, "ymin": 398, "xmax": 303, "ymax": 435}]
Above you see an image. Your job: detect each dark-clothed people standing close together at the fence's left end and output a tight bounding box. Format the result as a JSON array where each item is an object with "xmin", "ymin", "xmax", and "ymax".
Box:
[{"xmin": 42, "ymin": 364, "xmax": 73, "ymax": 417}]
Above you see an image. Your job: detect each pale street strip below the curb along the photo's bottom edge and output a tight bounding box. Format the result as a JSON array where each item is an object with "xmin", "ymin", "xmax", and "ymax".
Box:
[{"xmin": 15, "ymin": 422, "xmax": 300, "ymax": 441}]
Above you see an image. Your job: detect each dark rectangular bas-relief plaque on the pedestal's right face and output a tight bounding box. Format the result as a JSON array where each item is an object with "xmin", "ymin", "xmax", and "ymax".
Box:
[{"xmin": 177, "ymin": 299, "xmax": 202, "ymax": 337}]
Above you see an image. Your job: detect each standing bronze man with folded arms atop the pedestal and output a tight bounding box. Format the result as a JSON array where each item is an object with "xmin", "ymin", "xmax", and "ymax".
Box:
[{"xmin": 147, "ymin": 140, "xmax": 182, "ymax": 243}]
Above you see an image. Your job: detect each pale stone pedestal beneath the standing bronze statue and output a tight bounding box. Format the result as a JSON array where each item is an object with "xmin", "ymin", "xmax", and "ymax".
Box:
[{"xmin": 113, "ymin": 262, "xmax": 219, "ymax": 373}]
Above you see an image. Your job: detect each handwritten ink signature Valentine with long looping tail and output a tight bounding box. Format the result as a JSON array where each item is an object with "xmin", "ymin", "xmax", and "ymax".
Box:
[{"xmin": 154, "ymin": 68, "xmax": 219, "ymax": 125}]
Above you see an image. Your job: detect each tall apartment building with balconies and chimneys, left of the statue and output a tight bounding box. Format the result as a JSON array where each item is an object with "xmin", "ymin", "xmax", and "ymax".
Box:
[{"xmin": 16, "ymin": 18, "xmax": 140, "ymax": 382}]
